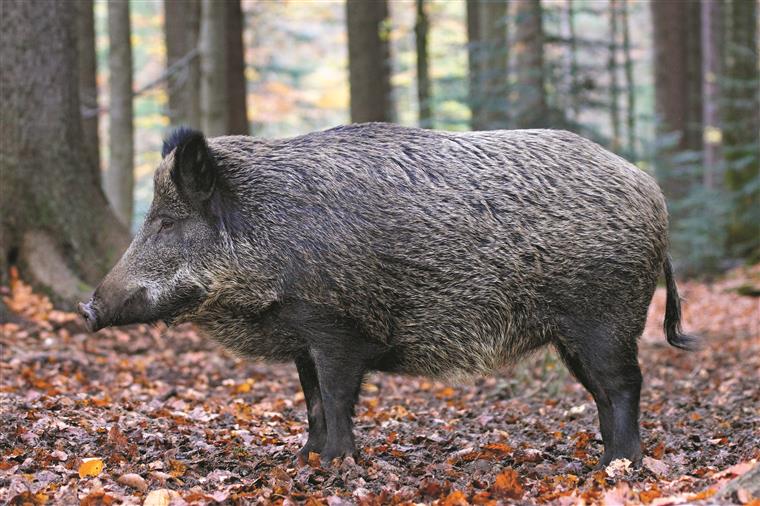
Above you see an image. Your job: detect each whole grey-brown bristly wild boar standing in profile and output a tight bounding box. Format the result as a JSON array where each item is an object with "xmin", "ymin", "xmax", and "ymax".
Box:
[{"xmin": 83, "ymin": 123, "xmax": 694, "ymax": 463}]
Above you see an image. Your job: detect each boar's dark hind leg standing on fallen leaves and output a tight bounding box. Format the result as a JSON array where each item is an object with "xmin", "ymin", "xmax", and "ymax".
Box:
[{"xmin": 557, "ymin": 329, "xmax": 641, "ymax": 466}]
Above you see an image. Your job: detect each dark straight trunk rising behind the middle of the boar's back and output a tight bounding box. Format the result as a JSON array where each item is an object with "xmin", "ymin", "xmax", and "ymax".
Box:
[{"xmin": 346, "ymin": 0, "xmax": 394, "ymax": 123}]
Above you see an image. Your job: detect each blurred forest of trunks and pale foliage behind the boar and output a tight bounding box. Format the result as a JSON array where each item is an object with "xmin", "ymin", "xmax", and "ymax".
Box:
[{"xmin": 0, "ymin": 0, "xmax": 760, "ymax": 303}]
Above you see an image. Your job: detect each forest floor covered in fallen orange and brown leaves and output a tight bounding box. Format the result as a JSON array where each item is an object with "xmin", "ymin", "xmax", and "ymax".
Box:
[{"xmin": 0, "ymin": 267, "xmax": 760, "ymax": 506}]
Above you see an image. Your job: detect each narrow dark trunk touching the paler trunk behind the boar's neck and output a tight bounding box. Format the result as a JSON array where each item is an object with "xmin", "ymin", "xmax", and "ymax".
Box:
[{"xmin": 224, "ymin": 0, "xmax": 248, "ymax": 135}]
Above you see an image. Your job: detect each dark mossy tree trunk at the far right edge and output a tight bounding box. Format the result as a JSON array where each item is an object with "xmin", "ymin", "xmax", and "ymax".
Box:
[{"xmin": 723, "ymin": 0, "xmax": 760, "ymax": 255}]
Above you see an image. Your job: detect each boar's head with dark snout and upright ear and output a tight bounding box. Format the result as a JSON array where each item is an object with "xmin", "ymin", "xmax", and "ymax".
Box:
[{"xmin": 79, "ymin": 129, "xmax": 232, "ymax": 331}]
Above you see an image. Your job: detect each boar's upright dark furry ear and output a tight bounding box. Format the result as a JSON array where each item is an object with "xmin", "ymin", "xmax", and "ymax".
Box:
[{"xmin": 171, "ymin": 130, "xmax": 217, "ymax": 207}]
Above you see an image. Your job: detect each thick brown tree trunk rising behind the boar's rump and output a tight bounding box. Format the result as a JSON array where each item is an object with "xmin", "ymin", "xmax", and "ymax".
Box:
[{"xmin": 649, "ymin": 1, "xmax": 702, "ymax": 199}]
